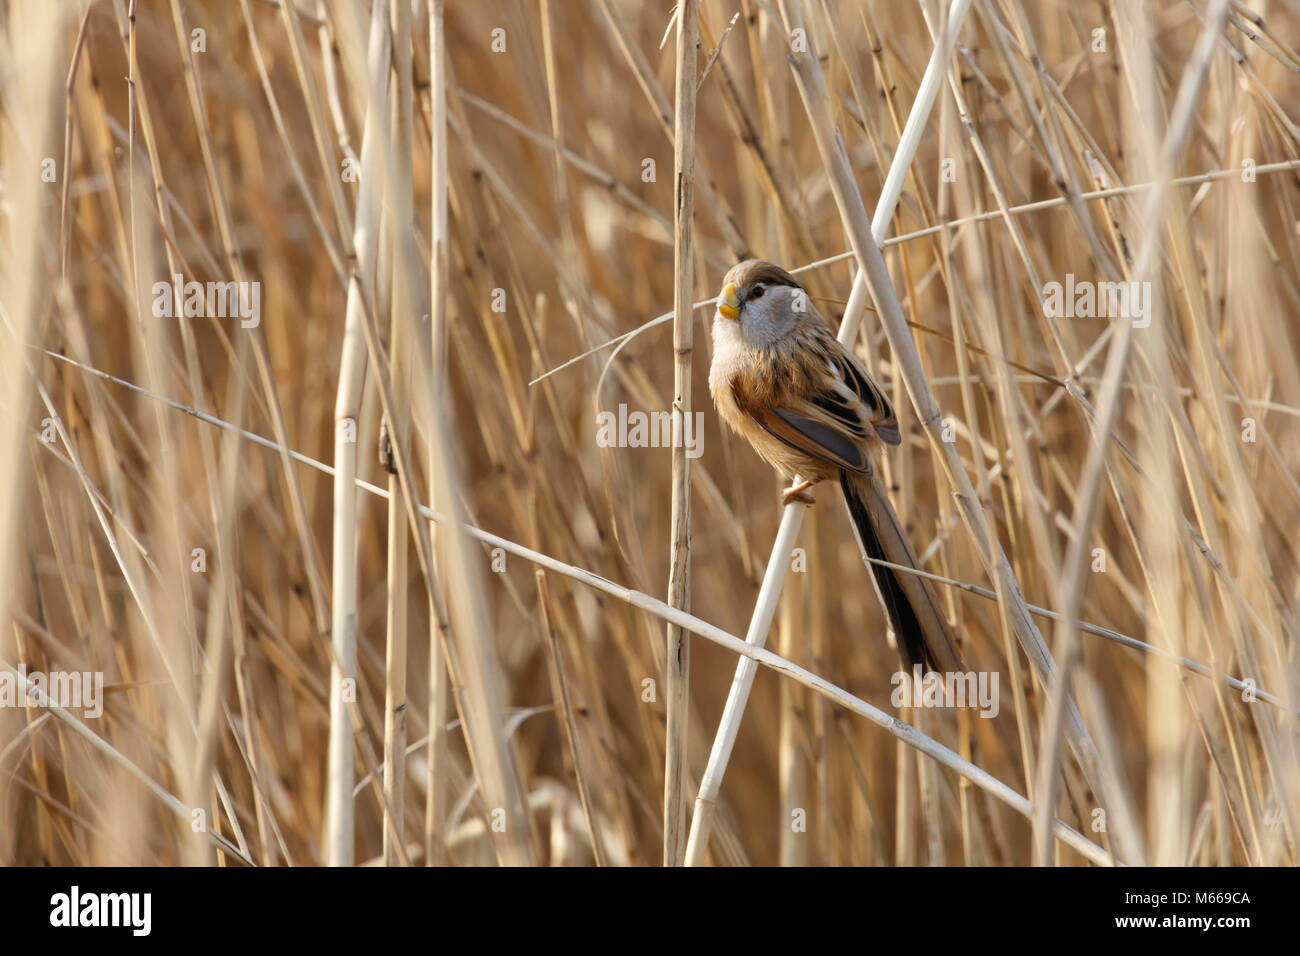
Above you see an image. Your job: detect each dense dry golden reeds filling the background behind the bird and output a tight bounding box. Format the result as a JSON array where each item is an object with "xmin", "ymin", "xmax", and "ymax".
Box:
[{"xmin": 0, "ymin": 0, "xmax": 1300, "ymax": 865}]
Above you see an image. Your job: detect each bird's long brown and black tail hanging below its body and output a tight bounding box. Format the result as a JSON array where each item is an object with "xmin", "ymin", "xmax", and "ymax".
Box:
[{"xmin": 840, "ymin": 471, "xmax": 965, "ymax": 672}]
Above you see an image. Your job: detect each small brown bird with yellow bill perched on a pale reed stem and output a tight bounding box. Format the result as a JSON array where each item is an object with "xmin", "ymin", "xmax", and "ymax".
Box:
[{"xmin": 709, "ymin": 259, "xmax": 965, "ymax": 671}]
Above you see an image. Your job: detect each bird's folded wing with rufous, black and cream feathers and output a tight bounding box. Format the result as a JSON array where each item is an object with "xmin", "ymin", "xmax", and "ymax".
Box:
[{"xmin": 732, "ymin": 349, "xmax": 900, "ymax": 472}]
